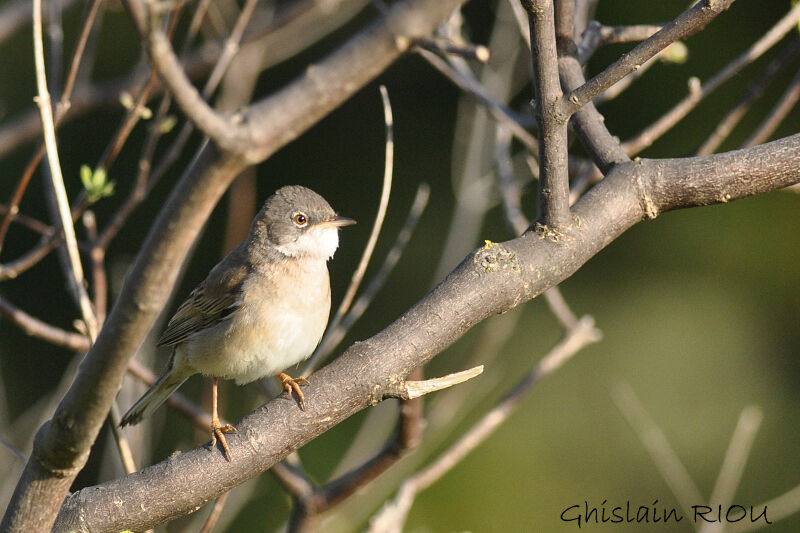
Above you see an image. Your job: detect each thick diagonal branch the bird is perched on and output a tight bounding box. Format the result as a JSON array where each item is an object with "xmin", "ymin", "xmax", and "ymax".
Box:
[{"xmin": 56, "ymin": 134, "xmax": 800, "ymax": 531}]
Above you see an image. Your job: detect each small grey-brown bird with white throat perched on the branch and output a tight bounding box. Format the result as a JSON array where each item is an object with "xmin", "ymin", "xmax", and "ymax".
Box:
[{"xmin": 120, "ymin": 185, "xmax": 356, "ymax": 461}]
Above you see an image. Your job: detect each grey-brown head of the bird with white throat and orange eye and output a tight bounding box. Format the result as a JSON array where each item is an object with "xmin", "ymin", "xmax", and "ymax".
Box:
[{"xmin": 250, "ymin": 185, "xmax": 356, "ymax": 260}]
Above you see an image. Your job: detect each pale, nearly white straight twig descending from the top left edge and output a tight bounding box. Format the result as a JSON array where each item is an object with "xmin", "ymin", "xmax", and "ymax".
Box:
[{"xmin": 33, "ymin": 0, "xmax": 97, "ymax": 339}]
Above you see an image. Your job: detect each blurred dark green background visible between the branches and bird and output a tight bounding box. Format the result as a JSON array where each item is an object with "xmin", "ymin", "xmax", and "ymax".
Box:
[{"xmin": 0, "ymin": 0, "xmax": 800, "ymax": 532}]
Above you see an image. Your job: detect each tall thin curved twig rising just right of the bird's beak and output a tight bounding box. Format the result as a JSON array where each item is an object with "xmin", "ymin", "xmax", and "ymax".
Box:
[{"xmin": 303, "ymin": 85, "xmax": 394, "ymax": 375}]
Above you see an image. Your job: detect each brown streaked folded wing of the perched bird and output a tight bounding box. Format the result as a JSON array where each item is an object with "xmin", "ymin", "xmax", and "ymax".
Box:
[{"xmin": 158, "ymin": 245, "xmax": 250, "ymax": 346}]
